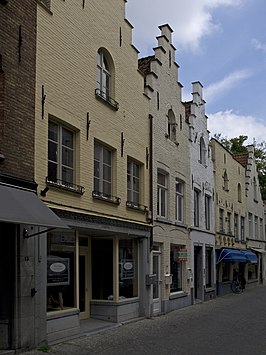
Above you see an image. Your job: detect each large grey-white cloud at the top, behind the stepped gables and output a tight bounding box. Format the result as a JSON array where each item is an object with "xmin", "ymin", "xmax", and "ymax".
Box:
[{"xmin": 126, "ymin": 0, "xmax": 244, "ymax": 55}]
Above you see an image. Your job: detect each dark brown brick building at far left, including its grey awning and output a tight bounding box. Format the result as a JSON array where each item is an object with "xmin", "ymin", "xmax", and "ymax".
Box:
[{"xmin": 0, "ymin": 0, "xmax": 64, "ymax": 349}]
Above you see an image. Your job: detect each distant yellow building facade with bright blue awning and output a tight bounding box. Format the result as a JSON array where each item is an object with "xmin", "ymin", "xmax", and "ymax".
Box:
[{"xmin": 211, "ymin": 139, "xmax": 257, "ymax": 295}]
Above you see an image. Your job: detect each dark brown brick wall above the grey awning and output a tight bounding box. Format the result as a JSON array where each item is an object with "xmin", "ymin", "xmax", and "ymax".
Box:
[{"xmin": 0, "ymin": 0, "xmax": 37, "ymax": 181}]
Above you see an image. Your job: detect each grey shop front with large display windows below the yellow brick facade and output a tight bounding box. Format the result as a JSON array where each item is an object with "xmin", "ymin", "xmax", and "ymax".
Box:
[{"xmin": 44, "ymin": 211, "xmax": 150, "ymax": 342}]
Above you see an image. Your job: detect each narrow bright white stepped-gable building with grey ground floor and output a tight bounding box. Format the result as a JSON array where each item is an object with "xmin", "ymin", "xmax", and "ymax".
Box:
[{"xmin": 185, "ymin": 82, "xmax": 216, "ymax": 302}]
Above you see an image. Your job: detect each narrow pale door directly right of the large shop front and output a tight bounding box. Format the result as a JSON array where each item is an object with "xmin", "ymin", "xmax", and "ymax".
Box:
[{"xmin": 152, "ymin": 252, "xmax": 161, "ymax": 314}]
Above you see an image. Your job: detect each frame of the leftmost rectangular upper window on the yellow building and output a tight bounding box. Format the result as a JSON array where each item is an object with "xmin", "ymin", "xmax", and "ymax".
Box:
[{"xmin": 48, "ymin": 120, "xmax": 76, "ymax": 187}]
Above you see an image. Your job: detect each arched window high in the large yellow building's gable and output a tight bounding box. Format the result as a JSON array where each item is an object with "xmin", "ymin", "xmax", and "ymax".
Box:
[{"xmin": 97, "ymin": 50, "xmax": 111, "ymax": 99}]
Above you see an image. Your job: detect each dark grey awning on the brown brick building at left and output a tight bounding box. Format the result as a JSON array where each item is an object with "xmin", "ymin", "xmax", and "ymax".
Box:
[{"xmin": 0, "ymin": 184, "xmax": 68, "ymax": 228}]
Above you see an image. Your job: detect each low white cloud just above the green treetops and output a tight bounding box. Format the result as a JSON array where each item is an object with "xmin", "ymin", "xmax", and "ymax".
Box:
[{"xmin": 208, "ymin": 110, "xmax": 266, "ymax": 144}]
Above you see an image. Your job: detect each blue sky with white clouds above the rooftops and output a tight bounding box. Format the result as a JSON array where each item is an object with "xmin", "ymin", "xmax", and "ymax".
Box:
[{"xmin": 126, "ymin": 0, "xmax": 266, "ymax": 144}]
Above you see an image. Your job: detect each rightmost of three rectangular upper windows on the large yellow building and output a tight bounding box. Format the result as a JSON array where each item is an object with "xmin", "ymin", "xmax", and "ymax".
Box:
[{"xmin": 127, "ymin": 159, "xmax": 140, "ymax": 205}]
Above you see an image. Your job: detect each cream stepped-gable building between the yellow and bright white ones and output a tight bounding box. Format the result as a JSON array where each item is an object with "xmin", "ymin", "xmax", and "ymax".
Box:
[{"xmin": 139, "ymin": 25, "xmax": 192, "ymax": 314}]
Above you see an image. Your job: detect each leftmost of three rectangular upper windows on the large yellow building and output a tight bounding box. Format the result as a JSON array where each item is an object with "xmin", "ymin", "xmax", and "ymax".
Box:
[{"xmin": 48, "ymin": 121, "xmax": 75, "ymax": 186}]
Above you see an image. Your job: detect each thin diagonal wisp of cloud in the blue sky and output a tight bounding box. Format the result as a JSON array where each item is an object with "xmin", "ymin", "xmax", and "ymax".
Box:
[{"xmin": 204, "ymin": 69, "xmax": 252, "ymax": 103}]
